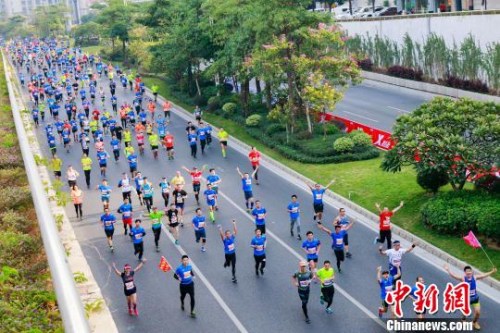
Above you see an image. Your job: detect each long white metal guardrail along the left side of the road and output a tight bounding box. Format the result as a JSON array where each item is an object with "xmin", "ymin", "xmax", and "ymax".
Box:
[{"xmin": 2, "ymin": 51, "xmax": 90, "ymax": 333}]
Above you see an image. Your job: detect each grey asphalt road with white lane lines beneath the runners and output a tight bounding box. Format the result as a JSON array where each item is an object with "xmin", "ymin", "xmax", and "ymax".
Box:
[{"xmin": 14, "ymin": 63, "xmax": 500, "ymax": 332}]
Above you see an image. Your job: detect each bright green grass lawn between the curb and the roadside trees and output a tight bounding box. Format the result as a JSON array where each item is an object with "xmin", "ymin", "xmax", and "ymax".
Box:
[{"xmin": 143, "ymin": 77, "xmax": 500, "ymax": 279}]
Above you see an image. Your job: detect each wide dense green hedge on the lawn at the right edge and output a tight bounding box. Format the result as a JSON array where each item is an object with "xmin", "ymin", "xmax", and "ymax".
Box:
[{"xmin": 421, "ymin": 190, "xmax": 500, "ymax": 242}]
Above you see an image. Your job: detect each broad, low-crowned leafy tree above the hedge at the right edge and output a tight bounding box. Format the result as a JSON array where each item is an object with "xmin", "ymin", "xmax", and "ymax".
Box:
[{"xmin": 381, "ymin": 97, "xmax": 500, "ymax": 191}]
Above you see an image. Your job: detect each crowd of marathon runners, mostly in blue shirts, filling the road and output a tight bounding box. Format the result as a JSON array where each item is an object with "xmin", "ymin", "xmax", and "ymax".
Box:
[{"xmin": 4, "ymin": 39, "xmax": 496, "ymax": 329}]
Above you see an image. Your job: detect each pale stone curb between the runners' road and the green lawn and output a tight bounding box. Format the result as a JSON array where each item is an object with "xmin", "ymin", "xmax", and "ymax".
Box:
[{"xmin": 147, "ymin": 88, "xmax": 500, "ymax": 294}]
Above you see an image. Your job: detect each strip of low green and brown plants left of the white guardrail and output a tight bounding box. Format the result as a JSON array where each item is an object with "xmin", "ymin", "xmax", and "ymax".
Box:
[{"xmin": 0, "ymin": 56, "xmax": 63, "ymax": 332}]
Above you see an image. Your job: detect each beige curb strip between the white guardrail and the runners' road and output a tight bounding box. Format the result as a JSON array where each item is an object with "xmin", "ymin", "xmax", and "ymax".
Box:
[{"xmin": 2, "ymin": 52, "xmax": 118, "ymax": 333}]
